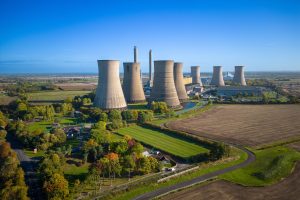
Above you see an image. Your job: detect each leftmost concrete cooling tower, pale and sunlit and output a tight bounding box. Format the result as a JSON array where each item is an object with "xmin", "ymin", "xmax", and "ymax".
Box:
[{"xmin": 94, "ymin": 60, "xmax": 127, "ymax": 110}]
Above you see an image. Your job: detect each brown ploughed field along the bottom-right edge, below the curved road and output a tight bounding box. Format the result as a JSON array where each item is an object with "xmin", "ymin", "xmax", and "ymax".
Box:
[{"xmin": 163, "ymin": 163, "xmax": 300, "ymax": 200}]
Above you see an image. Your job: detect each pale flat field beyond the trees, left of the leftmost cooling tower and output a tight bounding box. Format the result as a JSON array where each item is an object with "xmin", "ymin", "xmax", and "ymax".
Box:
[{"xmin": 28, "ymin": 90, "xmax": 90, "ymax": 101}]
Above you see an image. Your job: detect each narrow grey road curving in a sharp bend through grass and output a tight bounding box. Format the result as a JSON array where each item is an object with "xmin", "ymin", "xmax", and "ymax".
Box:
[{"xmin": 134, "ymin": 124, "xmax": 255, "ymax": 200}]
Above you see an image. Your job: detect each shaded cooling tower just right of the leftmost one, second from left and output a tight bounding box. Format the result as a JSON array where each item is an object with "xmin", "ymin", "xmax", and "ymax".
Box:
[{"xmin": 123, "ymin": 62, "xmax": 146, "ymax": 103}]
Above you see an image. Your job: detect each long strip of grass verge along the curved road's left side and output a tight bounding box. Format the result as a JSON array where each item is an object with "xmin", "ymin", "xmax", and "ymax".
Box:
[{"xmin": 106, "ymin": 146, "xmax": 247, "ymax": 200}]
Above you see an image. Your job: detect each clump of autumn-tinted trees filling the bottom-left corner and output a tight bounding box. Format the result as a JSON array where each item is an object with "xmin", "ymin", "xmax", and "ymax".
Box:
[{"xmin": 0, "ymin": 142, "xmax": 29, "ymax": 200}]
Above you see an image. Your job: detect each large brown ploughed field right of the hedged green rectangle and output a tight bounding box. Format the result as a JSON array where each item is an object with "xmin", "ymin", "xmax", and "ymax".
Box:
[{"xmin": 167, "ymin": 105, "xmax": 300, "ymax": 147}]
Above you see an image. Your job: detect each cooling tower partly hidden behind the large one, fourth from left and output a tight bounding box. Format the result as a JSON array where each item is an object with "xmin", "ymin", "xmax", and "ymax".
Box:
[{"xmin": 174, "ymin": 62, "xmax": 188, "ymax": 101}]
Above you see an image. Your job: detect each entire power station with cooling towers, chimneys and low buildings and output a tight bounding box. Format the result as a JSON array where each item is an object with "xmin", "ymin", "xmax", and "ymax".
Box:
[{"xmin": 94, "ymin": 46, "xmax": 248, "ymax": 110}]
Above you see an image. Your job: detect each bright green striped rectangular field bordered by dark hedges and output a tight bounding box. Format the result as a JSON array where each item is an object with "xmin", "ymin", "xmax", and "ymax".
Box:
[{"xmin": 117, "ymin": 125, "xmax": 208, "ymax": 158}]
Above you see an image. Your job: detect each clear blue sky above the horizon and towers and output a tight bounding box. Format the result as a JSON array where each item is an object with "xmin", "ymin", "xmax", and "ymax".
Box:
[{"xmin": 0, "ymin": 0, "xmax": 300, "ymax": 73}]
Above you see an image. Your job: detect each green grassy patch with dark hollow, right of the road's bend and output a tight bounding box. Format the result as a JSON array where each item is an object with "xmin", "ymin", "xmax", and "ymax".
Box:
[{"xmin": 220, "ymin": 146, "xmax": 300, "ymax": 186}]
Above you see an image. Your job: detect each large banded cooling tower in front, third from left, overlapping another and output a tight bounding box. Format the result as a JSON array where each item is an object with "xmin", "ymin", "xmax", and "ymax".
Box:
[{"xmin": 149, "ymin": 60, "xmax": 181, "ymax": 108}]
